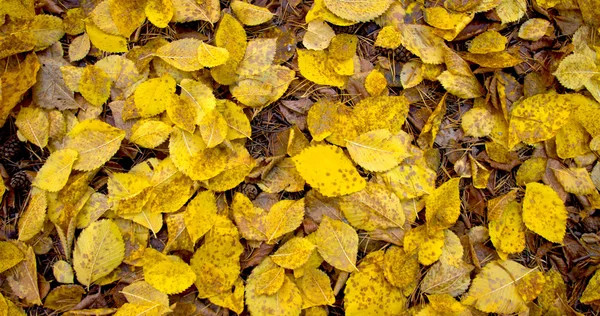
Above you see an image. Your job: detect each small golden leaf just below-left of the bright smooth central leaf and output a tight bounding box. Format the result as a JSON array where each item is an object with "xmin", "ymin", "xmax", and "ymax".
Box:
[{"xmin": 265, "ymin": 199, "xmax": 304, "ymax": 244}]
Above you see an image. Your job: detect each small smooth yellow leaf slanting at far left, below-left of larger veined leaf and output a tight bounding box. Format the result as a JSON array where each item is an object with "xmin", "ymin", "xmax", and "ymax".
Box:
[{"xmin": 32, "ymin": 149, "xmax": 78, "ymax": 192}]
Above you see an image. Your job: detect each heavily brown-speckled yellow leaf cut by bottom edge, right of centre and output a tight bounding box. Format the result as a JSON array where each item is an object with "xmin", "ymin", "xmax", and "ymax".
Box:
[{"xmin": 344, "ymin": 251, "xmax": 406, "ymax": 316}]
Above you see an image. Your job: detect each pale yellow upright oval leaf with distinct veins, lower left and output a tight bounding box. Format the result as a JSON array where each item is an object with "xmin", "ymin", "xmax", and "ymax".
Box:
[{"xmin": 73, "ymin": 219, "xmax": 125, "ymax": 286}]
